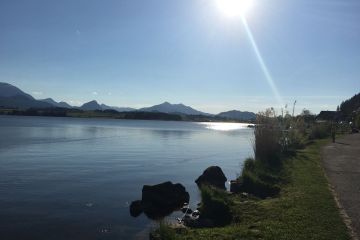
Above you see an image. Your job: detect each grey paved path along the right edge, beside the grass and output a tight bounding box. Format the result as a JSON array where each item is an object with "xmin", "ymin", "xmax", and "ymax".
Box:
[{"xmin": 323, "ymin": 134, "xmax": 360, "ymax": 239}]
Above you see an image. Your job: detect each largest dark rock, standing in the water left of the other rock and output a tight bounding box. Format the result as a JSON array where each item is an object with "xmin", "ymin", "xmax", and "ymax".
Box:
[{"xmin": 130, "ymin": 182, "xmax": 190, "ymax": 220}]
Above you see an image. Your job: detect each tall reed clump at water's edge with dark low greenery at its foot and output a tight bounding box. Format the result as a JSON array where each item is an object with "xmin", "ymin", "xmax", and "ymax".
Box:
[{"xmin": 238, "ymin": 109, "xmax": 284, "ymax": 198}]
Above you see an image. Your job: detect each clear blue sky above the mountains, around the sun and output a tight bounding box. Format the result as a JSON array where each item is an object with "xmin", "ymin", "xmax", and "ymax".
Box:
[{"xmin": 0, "ymin": 0, "xmax": 360, "ymax": 113}]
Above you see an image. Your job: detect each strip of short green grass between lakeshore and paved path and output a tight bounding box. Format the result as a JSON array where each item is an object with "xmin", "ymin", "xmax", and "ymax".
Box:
[{"xmin": 156, "ymin": 140, "xmax": 350, "ymax": 240}]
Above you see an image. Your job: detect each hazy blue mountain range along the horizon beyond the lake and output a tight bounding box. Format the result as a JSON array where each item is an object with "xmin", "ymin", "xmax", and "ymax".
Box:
[{"xmin": 0, "ymin": 82, "xmax": 256, "ymax": 120}]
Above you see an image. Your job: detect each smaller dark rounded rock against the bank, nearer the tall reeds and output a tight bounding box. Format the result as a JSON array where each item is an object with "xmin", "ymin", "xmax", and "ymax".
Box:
[{"xmin": 195, "ymin": 166, "xmax": 227, "ymax": 189}]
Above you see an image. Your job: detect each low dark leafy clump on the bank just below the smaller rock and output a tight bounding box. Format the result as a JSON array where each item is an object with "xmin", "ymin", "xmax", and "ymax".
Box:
[{"xmin": 200, "ymin": 186, "xmax": 232, "ymax": 226}]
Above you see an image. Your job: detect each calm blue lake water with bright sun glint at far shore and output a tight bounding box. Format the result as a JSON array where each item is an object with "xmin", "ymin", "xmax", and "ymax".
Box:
[{"xmin": 0, "ymin": 116, "xmax": 253, "ymax": 240}]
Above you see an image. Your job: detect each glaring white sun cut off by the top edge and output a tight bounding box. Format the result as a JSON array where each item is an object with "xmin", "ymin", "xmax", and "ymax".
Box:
[{"xmin": 216, "ymin": 0, "xmax": 254, "ymax": 17}]
